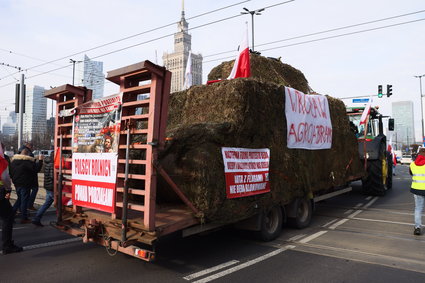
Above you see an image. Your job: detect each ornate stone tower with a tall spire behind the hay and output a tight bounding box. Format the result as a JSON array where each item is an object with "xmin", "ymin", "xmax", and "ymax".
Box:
[{"xmin": 162, "ymin": 4, "xmax": 202, "ymax": 92}]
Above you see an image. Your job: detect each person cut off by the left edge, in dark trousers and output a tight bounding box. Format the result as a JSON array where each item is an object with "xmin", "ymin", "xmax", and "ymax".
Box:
[{"xmin": 0, "ymin": 144, "xmax": 23, "ymax": 255}]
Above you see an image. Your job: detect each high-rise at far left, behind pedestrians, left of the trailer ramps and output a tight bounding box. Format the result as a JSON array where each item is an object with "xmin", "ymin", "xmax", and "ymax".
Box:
[{"xmin": 22, "ymin": 86, "xmax": 47, "ymax": 140}]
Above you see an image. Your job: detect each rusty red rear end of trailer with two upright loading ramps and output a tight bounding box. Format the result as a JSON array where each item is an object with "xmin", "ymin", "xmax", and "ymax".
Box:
[{"xmin": 45, "ymin": 61, "xmax": 199, "ymax": 261}]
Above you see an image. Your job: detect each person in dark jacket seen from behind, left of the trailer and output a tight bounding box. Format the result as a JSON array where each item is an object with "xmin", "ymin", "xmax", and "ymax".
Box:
[{"xmin": 10, "ymin": 149, "xmax": 37, "ymax": 224}]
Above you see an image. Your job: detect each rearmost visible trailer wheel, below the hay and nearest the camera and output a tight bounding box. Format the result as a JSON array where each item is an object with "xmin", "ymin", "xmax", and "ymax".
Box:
[{"xmin": 259, "ymin": 205, "xmax": 282, "ymax": 242}]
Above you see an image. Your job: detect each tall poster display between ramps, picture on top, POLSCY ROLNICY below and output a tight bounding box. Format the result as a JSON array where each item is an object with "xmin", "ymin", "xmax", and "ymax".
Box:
[{"xmin": 72, "ymin": 94, "xmax": 122, "ymax": 213}]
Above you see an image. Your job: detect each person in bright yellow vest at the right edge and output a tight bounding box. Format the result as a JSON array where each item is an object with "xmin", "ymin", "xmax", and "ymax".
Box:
[{"xmin": 410, "ymin": 147, "xmax": 425, "ymax": 235}]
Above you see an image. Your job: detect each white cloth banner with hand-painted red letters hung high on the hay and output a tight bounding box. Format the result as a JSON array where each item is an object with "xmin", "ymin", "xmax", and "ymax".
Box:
[{"xmin": 285, "ymin": 87, "xmax": 332, "ymax": 150}]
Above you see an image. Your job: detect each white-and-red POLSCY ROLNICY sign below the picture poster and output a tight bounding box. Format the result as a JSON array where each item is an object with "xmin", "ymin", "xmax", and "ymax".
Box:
[{"xmin": 72, "ymin": 152, "xmax": 118, "ymax": 213}]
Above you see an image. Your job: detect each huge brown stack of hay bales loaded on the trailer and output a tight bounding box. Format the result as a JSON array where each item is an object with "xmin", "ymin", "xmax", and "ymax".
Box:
[{"xmin": 158, "ymin": 55, "xmax": 363, "ymax": 223}]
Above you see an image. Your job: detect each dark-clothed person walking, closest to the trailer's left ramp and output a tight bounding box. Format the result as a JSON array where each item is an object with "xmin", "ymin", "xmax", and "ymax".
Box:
[{"xmin": 32, "ymin": 151, "xmax": 54, "ymax": 227}]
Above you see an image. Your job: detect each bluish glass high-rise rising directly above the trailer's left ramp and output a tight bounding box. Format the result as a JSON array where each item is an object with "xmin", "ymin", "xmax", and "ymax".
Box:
[{"xmin": 75, "ymin": 55, "xmax": 105, "ymax": 99}]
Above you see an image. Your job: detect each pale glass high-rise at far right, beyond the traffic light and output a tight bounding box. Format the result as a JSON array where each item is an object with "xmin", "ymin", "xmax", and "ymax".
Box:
[{"xmin": 392, "ymin": 101, "xmax": 415, "ymax": 149}]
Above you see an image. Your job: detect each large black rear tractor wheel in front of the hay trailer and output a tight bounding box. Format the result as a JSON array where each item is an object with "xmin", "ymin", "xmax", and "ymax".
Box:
[{"xmin": 363, "ymin": 144, "xmax": 388, "ymax": 196}]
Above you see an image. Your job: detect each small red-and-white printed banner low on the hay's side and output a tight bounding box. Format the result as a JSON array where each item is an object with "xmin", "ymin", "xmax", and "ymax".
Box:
[{"xmin": 221, "ymin": 147, "xmax": 270, "ymax": 198}]
